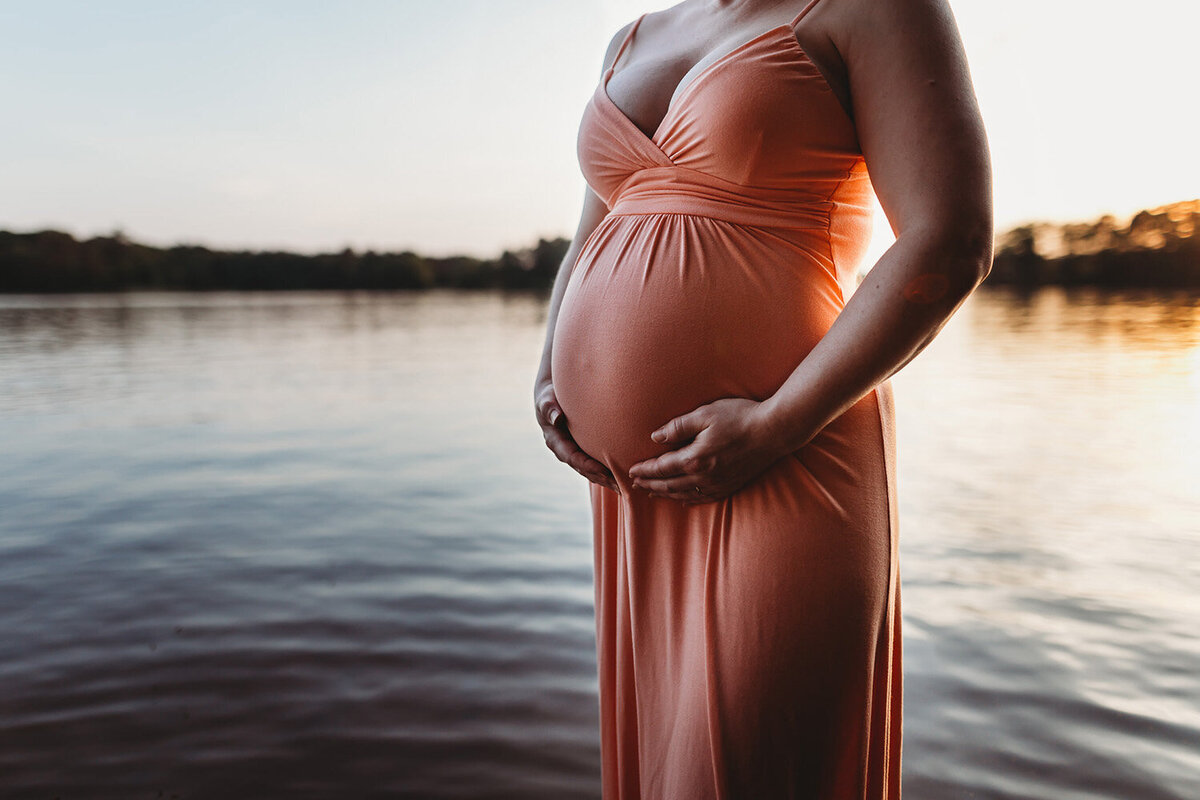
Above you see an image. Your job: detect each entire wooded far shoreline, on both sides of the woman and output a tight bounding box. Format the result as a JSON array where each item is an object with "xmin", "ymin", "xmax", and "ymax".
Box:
[{"xmin": 0, "ymin": 200, "xmax": 1200, "ymax": 294}]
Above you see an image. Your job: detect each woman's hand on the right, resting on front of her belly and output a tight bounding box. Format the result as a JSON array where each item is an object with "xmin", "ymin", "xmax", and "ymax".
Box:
[{"xmin": 629, "ymin": 397, "xmax": 787, "ymax": 503}]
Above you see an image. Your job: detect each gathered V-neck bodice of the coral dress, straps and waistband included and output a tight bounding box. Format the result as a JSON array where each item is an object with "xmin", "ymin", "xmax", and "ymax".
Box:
[{"xmin": 577, "ymin": 0, "xmax": 870, "ymax": 227}]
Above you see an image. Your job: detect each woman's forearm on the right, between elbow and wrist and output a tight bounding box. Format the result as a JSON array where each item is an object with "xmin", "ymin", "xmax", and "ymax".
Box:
[{"xmin": 763, "ymin": 227, "xmax": 991, "ymax": 452}]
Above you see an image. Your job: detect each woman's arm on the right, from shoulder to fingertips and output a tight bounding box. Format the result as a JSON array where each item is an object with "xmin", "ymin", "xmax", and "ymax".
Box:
[{"xmin": 630, "ymin": 0, "xmax": 992, "ymax": 503}]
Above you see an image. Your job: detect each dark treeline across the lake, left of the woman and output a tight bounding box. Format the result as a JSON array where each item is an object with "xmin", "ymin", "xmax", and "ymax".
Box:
[{"xmin": 0, "ymin": 230, "xmax": 570, "ymax": 293}]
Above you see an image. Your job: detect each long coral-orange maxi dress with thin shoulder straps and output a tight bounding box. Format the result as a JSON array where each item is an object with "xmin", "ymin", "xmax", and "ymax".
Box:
[{"xmin": 551, "ymin": 0, "xmax": 901, "ymax": 800}]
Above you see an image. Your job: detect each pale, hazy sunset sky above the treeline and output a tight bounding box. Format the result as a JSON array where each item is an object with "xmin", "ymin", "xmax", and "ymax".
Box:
[{"xmin": 0, "ymin": 0, "xmax": 1200, "ymax": 257}]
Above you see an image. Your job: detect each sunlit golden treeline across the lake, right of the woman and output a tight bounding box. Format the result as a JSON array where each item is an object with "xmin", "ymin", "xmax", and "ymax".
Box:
[{"xmin": 986, "ymin": 200, "xmax": 1200, "ymax": 287}]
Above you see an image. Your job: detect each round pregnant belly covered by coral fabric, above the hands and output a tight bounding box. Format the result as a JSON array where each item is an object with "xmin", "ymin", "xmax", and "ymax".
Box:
[{"xmin": 551, "ymin": 215, "xmax": 841, "ymax": 480}]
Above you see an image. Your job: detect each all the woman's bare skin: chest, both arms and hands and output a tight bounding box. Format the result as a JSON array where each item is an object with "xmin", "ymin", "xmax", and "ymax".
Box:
[{"xmin": 535, "ymin": 0, "xmax": 992, "ymax": 504}]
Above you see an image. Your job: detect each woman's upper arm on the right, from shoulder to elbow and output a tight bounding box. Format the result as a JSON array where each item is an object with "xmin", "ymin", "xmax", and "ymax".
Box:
[{"xmin": 838, "ymin": 0, "xmax": 992, "ymax": 266}]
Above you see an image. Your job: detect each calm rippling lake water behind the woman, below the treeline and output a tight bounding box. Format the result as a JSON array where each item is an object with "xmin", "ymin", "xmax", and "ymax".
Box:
[{"xmin": 0, "ymin": 289, "xmax": 1200, "ymax": 800}]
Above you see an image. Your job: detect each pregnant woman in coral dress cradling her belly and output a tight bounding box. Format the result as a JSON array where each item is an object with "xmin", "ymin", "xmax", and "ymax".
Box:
[{"xmin": 535, "ymin": 0, "xmax": 992, "ymax": 800}]
